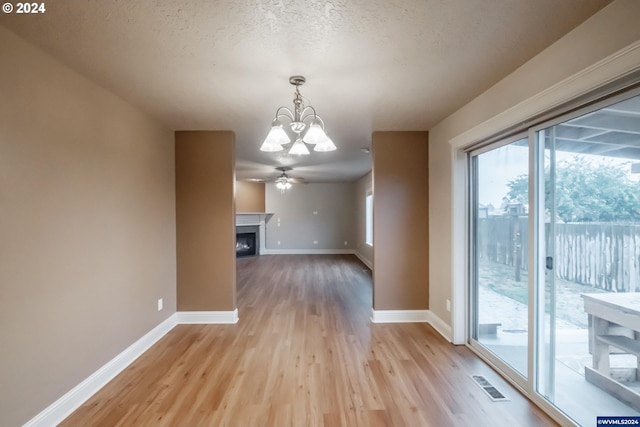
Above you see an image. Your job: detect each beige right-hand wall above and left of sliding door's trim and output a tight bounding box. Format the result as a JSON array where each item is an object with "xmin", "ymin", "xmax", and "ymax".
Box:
[{"xmin": 429, "ymin": 0, "xmax": 640, "ymax": 332}]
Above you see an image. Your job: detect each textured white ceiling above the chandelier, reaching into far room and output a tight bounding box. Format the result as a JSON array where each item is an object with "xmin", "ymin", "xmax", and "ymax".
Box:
[{"xmin": 0, "ymin": 0, "xmax": 609, "ymax": 182}]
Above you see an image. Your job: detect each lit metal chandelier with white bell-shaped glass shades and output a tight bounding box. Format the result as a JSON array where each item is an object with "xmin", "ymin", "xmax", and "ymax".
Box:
[{"xmin": 260, "ymin": 76, "xmax": 336, "ymax": 156}]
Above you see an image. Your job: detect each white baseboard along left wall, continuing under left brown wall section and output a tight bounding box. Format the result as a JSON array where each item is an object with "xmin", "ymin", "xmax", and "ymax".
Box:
[{"xmin": 23, "ymin": 308, "xmax": 238, "ymax": 427}]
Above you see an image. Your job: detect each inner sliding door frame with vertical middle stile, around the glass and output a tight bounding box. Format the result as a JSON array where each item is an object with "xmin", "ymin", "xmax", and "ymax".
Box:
[{"xmin": 462, "ymin": 85, "xmax": 640, "ymax": 423}]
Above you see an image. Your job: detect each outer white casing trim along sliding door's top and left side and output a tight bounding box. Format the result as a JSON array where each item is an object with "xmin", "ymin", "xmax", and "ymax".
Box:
[{"xmin": 448, "ymin": 41, "xmax": 640, "ymax": 424}]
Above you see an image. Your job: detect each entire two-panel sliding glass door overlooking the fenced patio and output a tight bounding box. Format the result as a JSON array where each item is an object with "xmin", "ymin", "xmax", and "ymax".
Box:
[{"xmin": 468, "ymin": 93, "xmax": 640, "ymax": 425}]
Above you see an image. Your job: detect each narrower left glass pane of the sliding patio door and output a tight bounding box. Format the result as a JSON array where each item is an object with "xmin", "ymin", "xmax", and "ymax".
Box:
[{"xmin": 471, "ymin": 138, "xmax": 529, "ymax": 377}]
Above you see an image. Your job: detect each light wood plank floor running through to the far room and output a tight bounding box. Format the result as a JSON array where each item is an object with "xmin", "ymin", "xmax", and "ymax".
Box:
[{"xmin": 61, "ymin": 255, "xmax": 554, "ymax": 427}]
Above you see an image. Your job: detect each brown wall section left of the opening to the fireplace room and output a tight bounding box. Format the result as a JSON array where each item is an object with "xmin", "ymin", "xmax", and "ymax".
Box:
[{"xmin": 175, "ymin": 131, "xmax": 236, "ymax": 311}]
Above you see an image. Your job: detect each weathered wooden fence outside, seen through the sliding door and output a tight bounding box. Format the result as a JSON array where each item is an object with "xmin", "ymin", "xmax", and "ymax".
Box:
[{"xmin": 477, "ymin": 216, "xmax": 640, "ymax": 292}]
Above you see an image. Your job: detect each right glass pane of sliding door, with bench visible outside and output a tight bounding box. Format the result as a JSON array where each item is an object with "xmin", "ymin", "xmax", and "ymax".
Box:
[{"xmin": 533, "ymin": 92, "xmax": 640, "ymax": 425}]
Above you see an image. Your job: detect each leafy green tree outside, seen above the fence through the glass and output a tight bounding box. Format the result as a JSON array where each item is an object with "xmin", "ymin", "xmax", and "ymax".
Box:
[{"xmin": 507, "ymin": 155, "xmax": 640, "ymax": 222}]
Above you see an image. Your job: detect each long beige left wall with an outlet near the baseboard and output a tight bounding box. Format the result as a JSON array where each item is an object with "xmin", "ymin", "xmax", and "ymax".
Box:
[{"xmin": 0, "ymin": 27, "xmax": 176, "ymax": 426}]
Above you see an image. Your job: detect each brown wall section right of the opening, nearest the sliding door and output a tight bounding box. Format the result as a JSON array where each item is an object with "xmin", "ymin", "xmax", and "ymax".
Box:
[{"xmin": 373, "ymin": 132, "xmax": 429, "ymax": 310}]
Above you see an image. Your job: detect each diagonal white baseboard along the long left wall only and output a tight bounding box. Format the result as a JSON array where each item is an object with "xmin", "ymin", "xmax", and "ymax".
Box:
[{"xmin": 23, "ymin": 314, "xmax": 177, "ymax": 427}]
